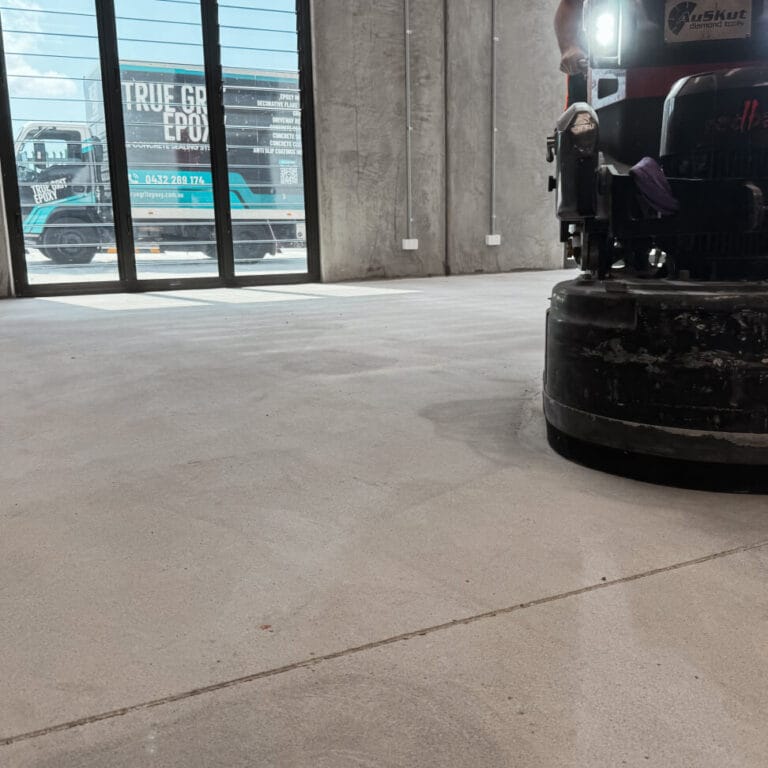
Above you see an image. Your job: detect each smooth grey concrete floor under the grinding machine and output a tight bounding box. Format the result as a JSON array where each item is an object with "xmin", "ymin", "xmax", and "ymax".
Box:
[{"xmin": 0, "ymin": 273, "xmax": 768, "ymax": 768}]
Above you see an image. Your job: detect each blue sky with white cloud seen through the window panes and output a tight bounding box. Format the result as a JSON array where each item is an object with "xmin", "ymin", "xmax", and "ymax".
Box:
[{"xmin": 0, "ymin": 0, "xmax": 298, "ymax": 134}]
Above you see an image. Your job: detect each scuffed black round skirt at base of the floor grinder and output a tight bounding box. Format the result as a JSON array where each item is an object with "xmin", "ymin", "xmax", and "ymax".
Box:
[{"xmin": 544, "ymin": 277, "xmax": 768, "ymax": 490}]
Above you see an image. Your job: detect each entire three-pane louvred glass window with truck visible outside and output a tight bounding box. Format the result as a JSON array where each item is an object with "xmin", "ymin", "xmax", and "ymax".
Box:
[{"xmin": 0, "ymin": 0, "xmax": 308, "ymax": 286}]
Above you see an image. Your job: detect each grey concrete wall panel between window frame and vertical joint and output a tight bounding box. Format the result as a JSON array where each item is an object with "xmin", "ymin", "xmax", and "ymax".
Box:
[{"xmin": 313, "ymin": 0, "xmax": 445, "ymax": 280}]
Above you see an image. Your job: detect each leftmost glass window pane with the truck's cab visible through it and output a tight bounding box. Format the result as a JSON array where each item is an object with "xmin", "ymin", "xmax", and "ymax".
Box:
[{"xmin": 0, "ymin": 0, "xmax": 118, "ymax": 284}]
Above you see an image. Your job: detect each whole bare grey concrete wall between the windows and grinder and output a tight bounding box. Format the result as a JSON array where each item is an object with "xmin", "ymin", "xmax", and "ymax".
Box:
[{"xmin": 313, "ymin": 0, "xmax": 565, "ymax": 280}]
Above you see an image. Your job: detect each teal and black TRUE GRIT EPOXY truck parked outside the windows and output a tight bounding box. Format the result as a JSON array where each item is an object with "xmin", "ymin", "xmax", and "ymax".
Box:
[{"xmin": 15, "ymin": 62, "xmax": 305, "ymax": 264}]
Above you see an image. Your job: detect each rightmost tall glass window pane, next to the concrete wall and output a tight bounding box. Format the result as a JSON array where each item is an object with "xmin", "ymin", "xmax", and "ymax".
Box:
[{"xmin": 219, "ymin": 0, "xmax": 307, "ymax": 275}]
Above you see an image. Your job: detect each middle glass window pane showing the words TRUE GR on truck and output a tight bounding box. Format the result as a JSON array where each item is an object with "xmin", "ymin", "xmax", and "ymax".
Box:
[{"xmin": 115, "ymin": 0, "xmax": 219, "ymax": 279}]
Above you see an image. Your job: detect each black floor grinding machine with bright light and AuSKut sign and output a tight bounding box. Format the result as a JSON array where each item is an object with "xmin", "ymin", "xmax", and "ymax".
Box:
[{"xmin": 544, "ymin": 0, "xmax": 768, "ymax": 490}]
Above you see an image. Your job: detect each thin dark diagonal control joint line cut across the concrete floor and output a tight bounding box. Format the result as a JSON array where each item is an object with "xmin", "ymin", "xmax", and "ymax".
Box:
[{"xmin": 0, "ymin": 540, "xmax": 768, "ymax": 747}]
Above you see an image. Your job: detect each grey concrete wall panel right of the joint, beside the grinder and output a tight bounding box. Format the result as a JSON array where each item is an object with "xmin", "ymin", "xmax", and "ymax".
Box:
[{"xmin": 446, "ymin": 0, "xmax": 565, "ymax": 273}]
